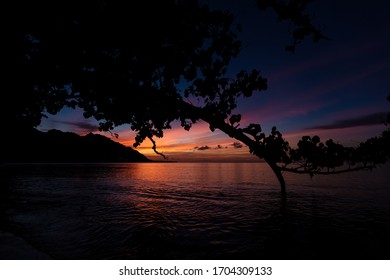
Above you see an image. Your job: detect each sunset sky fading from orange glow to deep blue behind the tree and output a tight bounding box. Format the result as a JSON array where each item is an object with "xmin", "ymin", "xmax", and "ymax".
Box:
[{"xmin": 38, "ymin": 0, "xmax": 390, "ymax": 161}]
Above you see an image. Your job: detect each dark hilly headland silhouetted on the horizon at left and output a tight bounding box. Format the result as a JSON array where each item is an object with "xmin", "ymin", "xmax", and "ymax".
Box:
[{"xmin": 1, "ymin": 129, "xmax": 152, "ymax": 163}]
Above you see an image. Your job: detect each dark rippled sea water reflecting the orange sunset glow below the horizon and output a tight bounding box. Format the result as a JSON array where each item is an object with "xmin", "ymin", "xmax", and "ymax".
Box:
[{"xmin": 1, "ymin": 163, "xmax": 390, "ymax": 260}]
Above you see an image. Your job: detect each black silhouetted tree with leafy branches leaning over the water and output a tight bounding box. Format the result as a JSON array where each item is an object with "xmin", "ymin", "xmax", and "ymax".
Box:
[{"xmin": 2, "ymin": 0, "xmax": 389, "ymax": 192}]
